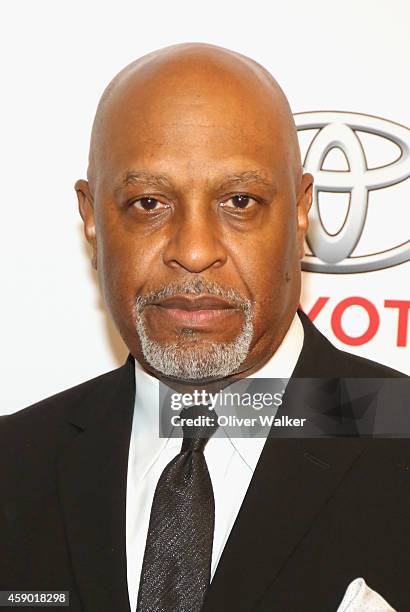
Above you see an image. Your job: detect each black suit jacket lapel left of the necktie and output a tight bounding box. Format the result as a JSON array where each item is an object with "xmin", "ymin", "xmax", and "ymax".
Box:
[{"xmin": 57, "ymin": 358, "xmax": 135, "ymax": 612}]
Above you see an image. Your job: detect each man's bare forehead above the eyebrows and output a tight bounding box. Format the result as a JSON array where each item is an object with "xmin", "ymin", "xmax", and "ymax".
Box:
[{"xmin": 96, "ymin": 69, "xmax": 289, "ymax": 190}]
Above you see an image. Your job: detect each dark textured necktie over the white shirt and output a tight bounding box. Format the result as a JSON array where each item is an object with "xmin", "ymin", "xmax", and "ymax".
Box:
[{"xmin": 137, "ymin": 405, "xmax": 218, "ymax": 612}]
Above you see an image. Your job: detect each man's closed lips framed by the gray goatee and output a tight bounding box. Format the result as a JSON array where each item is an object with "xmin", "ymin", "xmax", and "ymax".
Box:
[{"xmin": 146, "ymin": 295, "xmax": 239, "ymax": 327}]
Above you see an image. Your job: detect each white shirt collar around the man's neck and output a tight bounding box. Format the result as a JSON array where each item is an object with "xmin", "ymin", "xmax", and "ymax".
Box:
[{"xmin": 132, "ymin": 313, "xmax": 304, "ymax": 469}]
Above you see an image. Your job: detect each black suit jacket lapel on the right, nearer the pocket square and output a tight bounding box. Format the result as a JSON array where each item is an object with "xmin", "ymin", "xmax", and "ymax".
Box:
[{"xmin": 203, "ymin": 313, "xmax": 364, "ymax": 612}]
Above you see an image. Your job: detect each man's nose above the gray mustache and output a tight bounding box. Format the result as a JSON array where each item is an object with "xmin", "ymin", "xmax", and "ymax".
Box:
[{"xmin": 163, "ymin": 205, "xmax": 227, "ymax": 273}]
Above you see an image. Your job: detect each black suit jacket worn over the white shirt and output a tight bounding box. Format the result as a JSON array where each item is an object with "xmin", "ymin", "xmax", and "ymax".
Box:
[{"xmin": 0, "ymin": 312, "xmax": 410, "ymax": 612}]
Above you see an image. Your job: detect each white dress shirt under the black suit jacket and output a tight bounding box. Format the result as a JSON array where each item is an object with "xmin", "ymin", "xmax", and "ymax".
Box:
[{"xmin": 126, "ymin": 313, "xmax": 304, "ymax": 612}]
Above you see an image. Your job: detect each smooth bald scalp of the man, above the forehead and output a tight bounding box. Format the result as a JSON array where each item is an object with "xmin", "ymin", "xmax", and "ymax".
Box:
[{"xmin": 87, "ymin": 43, "xmax": 302, "ymax": 188}]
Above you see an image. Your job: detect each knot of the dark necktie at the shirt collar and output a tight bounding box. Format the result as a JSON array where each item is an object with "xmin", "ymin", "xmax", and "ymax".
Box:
[{"xmin": 180, "ymin": 404, "xmax": 218, "ymax": 453}]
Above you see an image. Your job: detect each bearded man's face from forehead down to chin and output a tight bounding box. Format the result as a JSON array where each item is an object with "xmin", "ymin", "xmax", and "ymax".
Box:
[{"xmin": 80, "ymin": 68, "xmax": 310, "ymax": 380}]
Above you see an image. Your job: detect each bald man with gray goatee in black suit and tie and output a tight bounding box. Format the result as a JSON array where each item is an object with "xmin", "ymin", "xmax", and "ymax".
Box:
[{"xmin": 0, "ymin": 44, "xmax": 410, "ymax": 612}]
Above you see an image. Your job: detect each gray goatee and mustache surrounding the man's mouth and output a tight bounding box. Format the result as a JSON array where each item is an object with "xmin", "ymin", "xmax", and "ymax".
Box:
[{"xmin": 135, "ymin": 277, "xmax": 253, "ymax": 381}]
